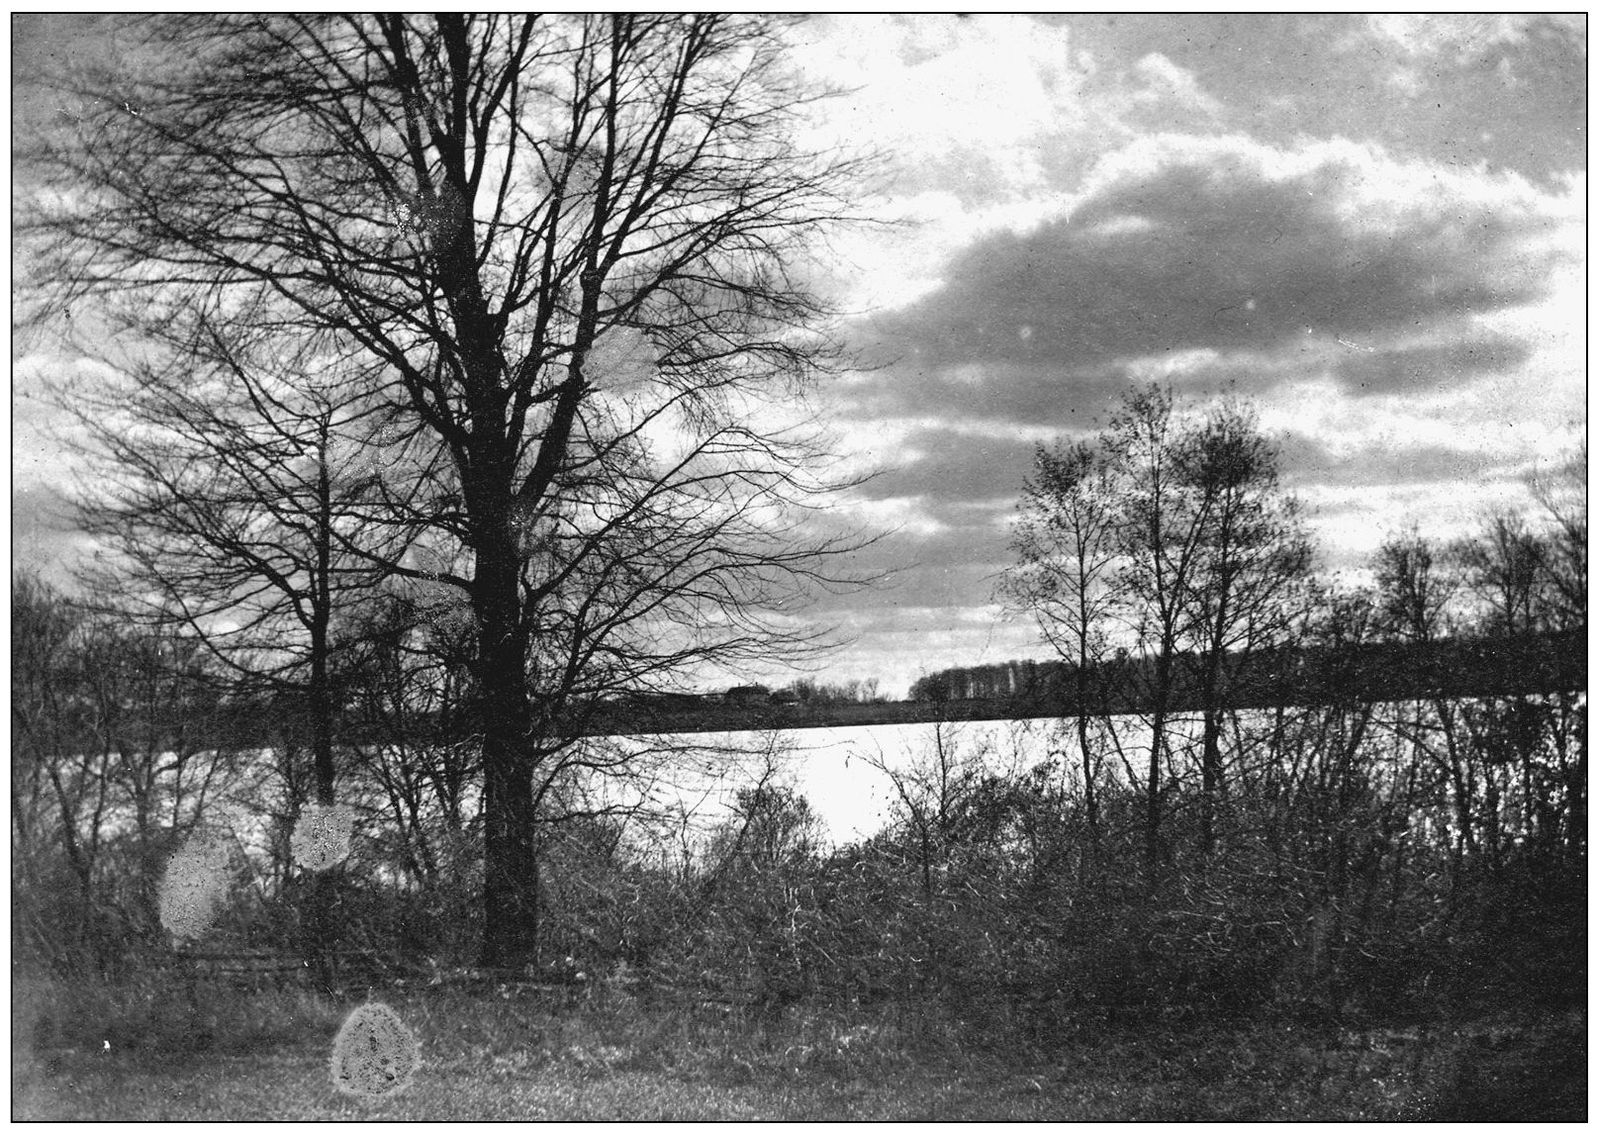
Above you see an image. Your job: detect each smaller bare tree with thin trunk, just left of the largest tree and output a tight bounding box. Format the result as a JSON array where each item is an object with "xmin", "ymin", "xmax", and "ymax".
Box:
[{"xmin": 53, "ymin": 323, "xmax": 428, "ymax": 805}]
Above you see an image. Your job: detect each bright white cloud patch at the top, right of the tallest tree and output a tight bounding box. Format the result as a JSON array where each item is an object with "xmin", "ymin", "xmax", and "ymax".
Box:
[{"xmin": 794, "ymin": 14, "xmax": 1124, "ymax": 310}]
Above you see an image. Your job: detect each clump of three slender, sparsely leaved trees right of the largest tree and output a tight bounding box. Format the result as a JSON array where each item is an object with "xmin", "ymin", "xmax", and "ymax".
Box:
[{"xmin": 1003, "ymin": 385, "xmax": 1311, "ymax": 877}]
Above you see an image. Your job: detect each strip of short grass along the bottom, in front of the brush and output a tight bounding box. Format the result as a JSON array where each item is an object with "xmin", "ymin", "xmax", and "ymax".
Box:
[{"xmin": 13, "ymin": 994, "xmax": 1586, "ymax": 1120}]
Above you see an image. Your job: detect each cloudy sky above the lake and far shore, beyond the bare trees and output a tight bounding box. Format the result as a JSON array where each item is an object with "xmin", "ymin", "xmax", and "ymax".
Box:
[{"xmin": 13, "ymin": 14, "xmax": 1587, "ymax": 693}]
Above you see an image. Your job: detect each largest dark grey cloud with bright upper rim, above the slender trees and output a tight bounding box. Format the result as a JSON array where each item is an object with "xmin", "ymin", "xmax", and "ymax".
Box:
[{"xmin": 859, "ymin": 139, "xmax": 1578, "ymax": 423}]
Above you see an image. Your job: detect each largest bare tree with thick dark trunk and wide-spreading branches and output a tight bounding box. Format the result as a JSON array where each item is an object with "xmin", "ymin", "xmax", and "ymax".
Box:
[{"xmin": 24, "ymin": 14, "xmax": 858, "ymax": 965}]
